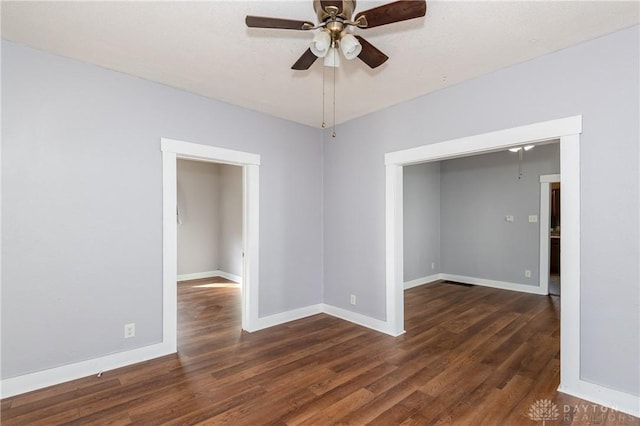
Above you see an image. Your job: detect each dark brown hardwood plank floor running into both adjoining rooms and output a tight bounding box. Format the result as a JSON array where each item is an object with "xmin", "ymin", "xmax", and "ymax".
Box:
[{"xmin": 1, "ymin": 280, "xmax": 640, "ymax": 425}]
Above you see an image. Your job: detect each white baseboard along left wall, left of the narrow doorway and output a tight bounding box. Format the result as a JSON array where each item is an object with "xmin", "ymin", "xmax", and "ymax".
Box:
[{"xmin": 0, "ymin": 343, "xmax": 175, "ymax": 398}]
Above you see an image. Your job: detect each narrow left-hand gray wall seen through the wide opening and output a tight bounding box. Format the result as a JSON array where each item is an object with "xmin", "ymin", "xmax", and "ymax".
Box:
[{"xmin": 403, "ymin": 162, "xmax": 442, "ymax": 281}]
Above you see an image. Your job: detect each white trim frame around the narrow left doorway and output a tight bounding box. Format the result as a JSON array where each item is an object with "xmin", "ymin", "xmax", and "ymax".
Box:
[{"xmin": 160, "ymin": 138, "xmax": 260, "ymax": 352}]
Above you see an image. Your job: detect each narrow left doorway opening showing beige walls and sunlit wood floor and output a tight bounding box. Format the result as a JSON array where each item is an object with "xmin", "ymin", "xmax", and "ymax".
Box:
[{"xmin": 176, "ymin": 158, "xmax": 243, "ymax": 355}]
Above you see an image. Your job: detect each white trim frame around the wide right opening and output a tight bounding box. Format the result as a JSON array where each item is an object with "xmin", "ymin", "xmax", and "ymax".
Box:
[{"xmin": 385, "ymin": 116, "xmax": 582, "ymax": 393}]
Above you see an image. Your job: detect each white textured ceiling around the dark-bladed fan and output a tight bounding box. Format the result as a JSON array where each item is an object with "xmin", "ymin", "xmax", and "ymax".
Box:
[{"xmin": 1, "ymin": 0, "xmax": 640, "ymax": 127}]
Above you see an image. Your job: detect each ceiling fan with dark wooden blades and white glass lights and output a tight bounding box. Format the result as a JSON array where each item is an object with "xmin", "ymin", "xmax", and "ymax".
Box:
[{"xmin": 245, "ymin": 0, "xmax": 427, "ymax": 70}]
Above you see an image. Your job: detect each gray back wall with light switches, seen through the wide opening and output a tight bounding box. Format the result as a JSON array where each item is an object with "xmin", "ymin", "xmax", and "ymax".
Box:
[{"xmin": 440, "ymin": 143, "xmax": 560, "ymax": 286}]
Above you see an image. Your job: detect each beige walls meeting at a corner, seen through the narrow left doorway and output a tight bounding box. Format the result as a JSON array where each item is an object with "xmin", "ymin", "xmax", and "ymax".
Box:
[{"xmin": 177, "ymin": 160, "xmax": 242, "ymax": 275}]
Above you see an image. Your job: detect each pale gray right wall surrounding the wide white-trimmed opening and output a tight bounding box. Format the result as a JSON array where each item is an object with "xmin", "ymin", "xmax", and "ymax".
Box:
[{"xmin": 323, "ymin": 26, "xmax": 640, "ymax": 394}]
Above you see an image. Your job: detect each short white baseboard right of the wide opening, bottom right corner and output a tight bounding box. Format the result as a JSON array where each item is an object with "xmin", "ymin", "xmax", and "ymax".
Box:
[{"xmin": 558, "ymin": 380, "xmax": 640, "ymax": 416}]
